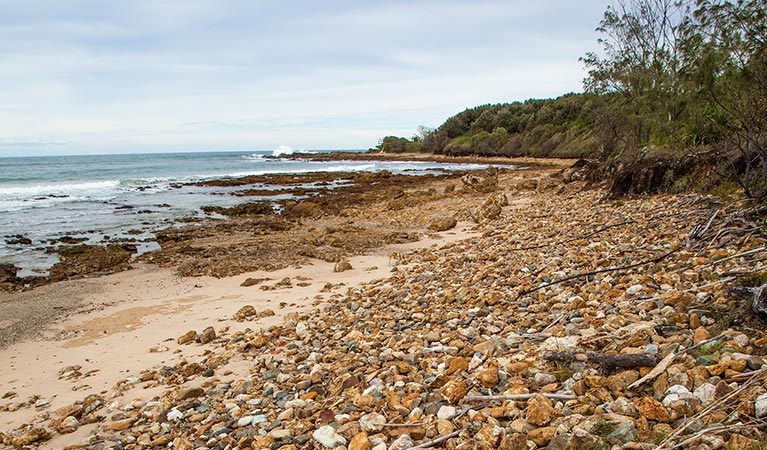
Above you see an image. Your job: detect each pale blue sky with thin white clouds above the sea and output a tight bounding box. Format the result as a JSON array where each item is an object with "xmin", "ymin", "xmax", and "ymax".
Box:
[{"xmin": 0, "ymin": 0, "xmax": 609, "ymax": 156}]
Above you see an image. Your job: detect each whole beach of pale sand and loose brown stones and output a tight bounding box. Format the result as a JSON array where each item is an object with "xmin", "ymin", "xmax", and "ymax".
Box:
[{"xmin": 0, "ymin": 156, "xmax": 767, "ymax": 450}]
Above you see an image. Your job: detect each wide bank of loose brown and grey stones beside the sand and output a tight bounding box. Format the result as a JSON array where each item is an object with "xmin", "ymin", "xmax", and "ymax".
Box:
[{"xmin": 0, "ymin": 160, "xmax": 767, "ymax": 450}]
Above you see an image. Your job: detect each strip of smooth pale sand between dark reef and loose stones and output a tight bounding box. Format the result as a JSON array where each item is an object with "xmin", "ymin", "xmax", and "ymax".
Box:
[{"xmin": 0, "ymin": 223, "xmax": 472, "ymax": 448}]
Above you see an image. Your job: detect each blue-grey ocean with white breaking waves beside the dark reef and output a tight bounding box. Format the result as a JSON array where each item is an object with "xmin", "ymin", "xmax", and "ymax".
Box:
[{"xmin": 0, "ymin": 148, "xmax": 504, "ymax": 276}]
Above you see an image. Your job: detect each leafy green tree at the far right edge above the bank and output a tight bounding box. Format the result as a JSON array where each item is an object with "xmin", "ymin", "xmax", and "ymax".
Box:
[{"xmin": 683, "ymin": 0, "xmax": 767, "ymax": 201}]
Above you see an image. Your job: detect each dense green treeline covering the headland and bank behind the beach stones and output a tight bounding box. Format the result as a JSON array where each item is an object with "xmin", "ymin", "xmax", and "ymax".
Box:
[{"xmin": 378, "ymin": 0, "xmax": 767, "ymax": 201}]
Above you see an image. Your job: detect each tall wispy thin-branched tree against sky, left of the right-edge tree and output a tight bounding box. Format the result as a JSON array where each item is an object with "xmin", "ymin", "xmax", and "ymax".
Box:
[{"xmin": 581, "ymin": 0, "xmax": 690, "ymax": 152}]
